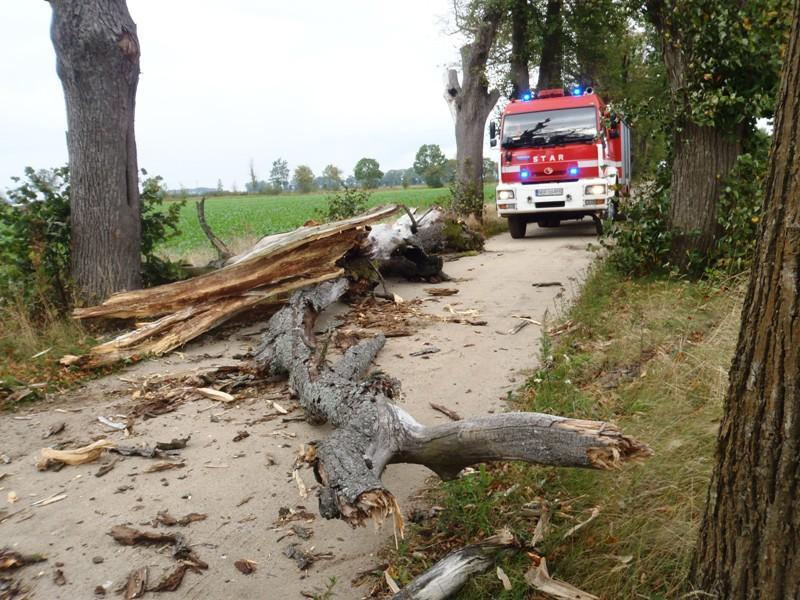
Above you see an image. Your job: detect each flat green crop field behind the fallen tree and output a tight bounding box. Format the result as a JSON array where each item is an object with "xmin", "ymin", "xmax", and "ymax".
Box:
[{"xmin": 160, "ymin": 183, "xmax": 495, "ymax": 259}]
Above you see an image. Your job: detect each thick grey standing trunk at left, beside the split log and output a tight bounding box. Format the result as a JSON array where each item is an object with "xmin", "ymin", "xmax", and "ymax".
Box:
[{"xmin": 50, "ymin": 0, "xmax": 141, "ymax": 301}]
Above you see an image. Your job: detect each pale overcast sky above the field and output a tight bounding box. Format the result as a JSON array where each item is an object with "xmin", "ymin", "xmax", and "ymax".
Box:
[{"xmin": 0, "ymin": 0, "xmax": 466, "ymax": 190}]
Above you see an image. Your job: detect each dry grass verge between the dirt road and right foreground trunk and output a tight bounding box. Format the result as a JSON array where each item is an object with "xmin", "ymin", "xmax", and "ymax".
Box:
[{"xmin": 388, "ymin": 264, "xmax": 742, "ymax": 600}]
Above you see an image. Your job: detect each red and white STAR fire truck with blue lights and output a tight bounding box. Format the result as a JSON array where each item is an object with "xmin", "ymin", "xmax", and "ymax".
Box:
[{"xmin": 489, "ymin": 88, "xmax": 631, "ymax": 238}]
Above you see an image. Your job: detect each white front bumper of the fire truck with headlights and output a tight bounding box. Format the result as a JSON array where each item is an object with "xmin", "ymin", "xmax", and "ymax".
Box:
[{"xmin": 495, "ymin": 178, "xmax": 614, "ymax": 222}]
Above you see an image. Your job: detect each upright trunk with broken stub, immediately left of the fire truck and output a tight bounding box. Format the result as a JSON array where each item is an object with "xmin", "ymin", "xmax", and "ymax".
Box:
[{"xmin": 444, "ymin": 6, "xmax": 502, "ymax": 218}]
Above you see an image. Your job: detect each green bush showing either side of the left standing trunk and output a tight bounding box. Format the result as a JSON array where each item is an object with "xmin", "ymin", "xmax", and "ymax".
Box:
[{"xmin": 0, "ymin": 167, "xmax": 182, "ymax": 319}]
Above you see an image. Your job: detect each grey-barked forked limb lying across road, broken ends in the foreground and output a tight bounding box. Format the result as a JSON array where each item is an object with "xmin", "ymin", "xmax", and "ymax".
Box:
[{"xmin": 254, "ymin": 280, "xmax": 650, "ymax": 532}]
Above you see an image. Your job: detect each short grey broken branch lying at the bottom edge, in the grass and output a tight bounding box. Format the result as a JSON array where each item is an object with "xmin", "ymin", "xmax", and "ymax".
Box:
[{"xmin": 392, "ymin": 530, "xmax": 514, "ymax": 600}]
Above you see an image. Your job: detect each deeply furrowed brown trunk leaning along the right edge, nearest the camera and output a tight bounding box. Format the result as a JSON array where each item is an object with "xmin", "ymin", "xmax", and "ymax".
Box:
[{"xmin": 693, "ymin": 2, "xmax": 800, "ymax": 600}]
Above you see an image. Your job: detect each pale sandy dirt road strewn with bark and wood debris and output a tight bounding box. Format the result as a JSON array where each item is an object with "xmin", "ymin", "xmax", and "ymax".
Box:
[{"xmin": 0, "ymin": 222, "xmax": 594, "ymax": 600}]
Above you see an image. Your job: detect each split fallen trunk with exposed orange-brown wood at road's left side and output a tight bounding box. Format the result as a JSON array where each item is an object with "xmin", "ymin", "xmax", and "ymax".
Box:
[{"xmin": 67, "ymin": 205, "xmax": 462, "ymax": 367}]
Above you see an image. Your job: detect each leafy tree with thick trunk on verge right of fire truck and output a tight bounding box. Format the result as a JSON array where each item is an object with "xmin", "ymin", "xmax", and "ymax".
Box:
[{"xmin": 646, "ymin": 0, "xmax": 786, "ymax": 267}]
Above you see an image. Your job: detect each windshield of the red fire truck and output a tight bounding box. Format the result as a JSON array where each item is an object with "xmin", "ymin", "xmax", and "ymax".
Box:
[{"xmin": 502, "ymin": 106, "xmax": 597, "ymax": 148}]
